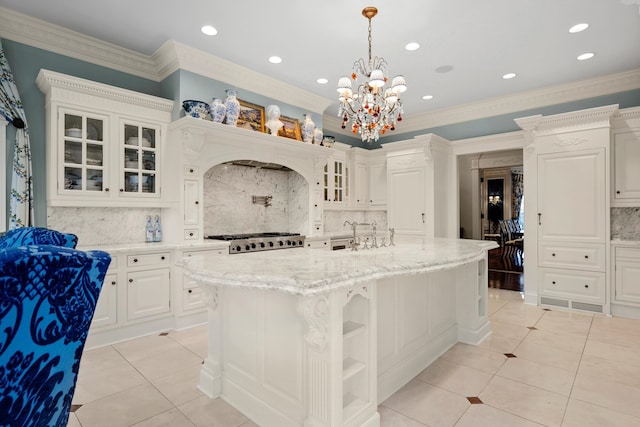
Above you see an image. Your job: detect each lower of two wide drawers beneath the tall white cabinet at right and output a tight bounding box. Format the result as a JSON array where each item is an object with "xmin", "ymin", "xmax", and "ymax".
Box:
[{"xmin": 540, "ymin": 268, "xmax": 605, "ymax": 304}]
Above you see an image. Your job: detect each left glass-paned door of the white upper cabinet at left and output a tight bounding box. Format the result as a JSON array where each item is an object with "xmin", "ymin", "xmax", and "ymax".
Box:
[{"xmin": 58, "ymin": 110, "xmax": 109, "ymax": 195}]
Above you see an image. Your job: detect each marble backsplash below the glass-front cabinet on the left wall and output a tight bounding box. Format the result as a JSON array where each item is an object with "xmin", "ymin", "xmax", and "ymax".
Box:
[{"xmin": 47, "ymin": 207, "xmax": 162, "ymax": 246}]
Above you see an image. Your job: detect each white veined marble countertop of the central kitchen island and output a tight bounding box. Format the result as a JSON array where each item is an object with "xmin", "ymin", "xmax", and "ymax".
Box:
[{"xmin": 184, "ymin": 239, "xmax": 498, "ymax": 295}]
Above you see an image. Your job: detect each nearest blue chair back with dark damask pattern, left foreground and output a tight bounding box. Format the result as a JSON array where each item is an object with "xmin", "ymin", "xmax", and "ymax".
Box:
[{"xmin": 0, "ymin": 245, "xmax": 111, "ymax": 427}]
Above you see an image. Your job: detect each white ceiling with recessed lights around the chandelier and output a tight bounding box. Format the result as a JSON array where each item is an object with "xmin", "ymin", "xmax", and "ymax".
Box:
[{"xmin": 0, "ymin": 0, "xmax": 640, "ymax": 123}]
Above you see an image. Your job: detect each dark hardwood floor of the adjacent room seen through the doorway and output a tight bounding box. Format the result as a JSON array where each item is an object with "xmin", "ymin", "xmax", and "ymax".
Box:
[{"xmin": 489, "ymin": 247, "xmax": 524, "ymax": 292}]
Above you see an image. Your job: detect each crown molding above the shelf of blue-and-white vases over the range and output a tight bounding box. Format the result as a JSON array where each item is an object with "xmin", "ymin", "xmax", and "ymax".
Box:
[{"xmin": 152, "ymin": 40, "xmax": 333, "ymax": 115}]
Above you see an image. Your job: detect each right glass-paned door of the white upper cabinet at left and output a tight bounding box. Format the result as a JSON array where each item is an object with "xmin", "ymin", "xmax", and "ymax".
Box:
[{"xmin": 120, "ymin": 121, "xmax": 160, "ymax": 196}]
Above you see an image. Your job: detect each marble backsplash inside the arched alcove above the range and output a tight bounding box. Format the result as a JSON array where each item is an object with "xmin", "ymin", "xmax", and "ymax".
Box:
[{"xmin": 203, "ymin": 164, "xmax": 309, "ymax": 236}]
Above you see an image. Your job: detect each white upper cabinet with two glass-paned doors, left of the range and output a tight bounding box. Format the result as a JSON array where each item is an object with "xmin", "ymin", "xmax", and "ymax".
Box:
[{"xmin": 36, "ymin": 70, "xmax": 173, "ymax": 207}]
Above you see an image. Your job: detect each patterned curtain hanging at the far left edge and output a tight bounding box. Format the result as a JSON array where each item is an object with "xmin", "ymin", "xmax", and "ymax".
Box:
[{"xmin": 0, "ymin": 42, "xmax": 34, "ymax": 229}]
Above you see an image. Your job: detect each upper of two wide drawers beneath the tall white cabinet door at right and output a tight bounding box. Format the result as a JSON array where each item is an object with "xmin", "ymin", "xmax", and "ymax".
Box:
[{"xmin": 538, "ymin": 243, "xmax": 605, "ymax": 271}]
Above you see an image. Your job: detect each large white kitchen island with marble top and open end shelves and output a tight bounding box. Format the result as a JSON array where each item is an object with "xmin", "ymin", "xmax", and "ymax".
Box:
[{"xmin": 184, "ymin": 239, "xmax": 497, "ymax": 427}]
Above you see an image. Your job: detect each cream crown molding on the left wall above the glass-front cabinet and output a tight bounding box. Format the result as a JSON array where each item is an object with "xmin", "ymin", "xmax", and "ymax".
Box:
[{"xmin": 0, "ymin": 6, "xmax": 159, "ymax": 81}]
